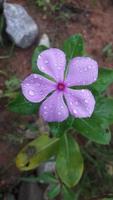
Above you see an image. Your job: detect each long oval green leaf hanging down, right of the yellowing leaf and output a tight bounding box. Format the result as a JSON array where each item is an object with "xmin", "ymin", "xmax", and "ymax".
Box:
[{"xmin": 56, "ymin": 134, "xmax": 83, "ymax": 187}]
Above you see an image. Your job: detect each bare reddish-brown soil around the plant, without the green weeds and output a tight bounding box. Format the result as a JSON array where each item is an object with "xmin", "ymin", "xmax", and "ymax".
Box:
[{"xmin": 0, "ymin": 0, "xmax": 113, "ymax": 194}]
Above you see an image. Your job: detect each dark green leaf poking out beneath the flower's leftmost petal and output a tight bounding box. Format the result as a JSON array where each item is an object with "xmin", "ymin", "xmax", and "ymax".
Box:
[{"xmin": 8, "ymin": 94, "xmax": 39, "ymax": 115}]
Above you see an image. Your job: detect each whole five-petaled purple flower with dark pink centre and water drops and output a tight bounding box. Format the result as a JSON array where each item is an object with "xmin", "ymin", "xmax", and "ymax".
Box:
[{"xmin": 21, "ymin": 48, "xmax": 98, "ymax": 122}]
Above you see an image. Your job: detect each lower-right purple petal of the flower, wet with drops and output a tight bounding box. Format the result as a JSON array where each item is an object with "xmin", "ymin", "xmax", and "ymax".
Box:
[{"xmin": 64, "ymin": 89, "xmax": 95, "ymax": 118}]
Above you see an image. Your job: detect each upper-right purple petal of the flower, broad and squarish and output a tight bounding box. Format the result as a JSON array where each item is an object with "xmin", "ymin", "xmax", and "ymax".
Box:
[{"xmin": 66, "ymin": 57, "xmax": 98, "ymax": 86}]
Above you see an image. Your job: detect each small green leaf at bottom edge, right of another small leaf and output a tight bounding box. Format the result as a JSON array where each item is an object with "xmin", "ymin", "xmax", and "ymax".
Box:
[{"xmin": 62, "ymin": 185, "xmax": 75, "ymax": 200}]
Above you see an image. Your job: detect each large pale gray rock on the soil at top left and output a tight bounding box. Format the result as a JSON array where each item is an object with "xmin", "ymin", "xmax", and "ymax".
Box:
[{"xmin": 4, "ymin": 3, "xmax": 38, "ymax": 48}]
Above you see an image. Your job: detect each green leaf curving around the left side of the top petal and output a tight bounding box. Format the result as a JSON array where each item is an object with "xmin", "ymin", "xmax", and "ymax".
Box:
[{"xmin": 32, "ymin": 46, "xmax": 47, "ymax": 74}]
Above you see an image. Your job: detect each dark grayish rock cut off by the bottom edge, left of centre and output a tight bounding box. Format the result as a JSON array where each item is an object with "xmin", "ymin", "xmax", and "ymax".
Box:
[{"xmin": 18, "ymin": 182, "xmax": 44, "ymax": 200}]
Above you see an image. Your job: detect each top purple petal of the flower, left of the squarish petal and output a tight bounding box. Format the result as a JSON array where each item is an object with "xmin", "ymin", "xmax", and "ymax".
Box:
[{"xmin": 37, "ymin": 48, "xmax": 66, "ymax": 81}]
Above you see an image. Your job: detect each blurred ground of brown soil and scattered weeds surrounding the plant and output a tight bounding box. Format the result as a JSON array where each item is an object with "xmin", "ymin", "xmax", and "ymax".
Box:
[{"xmin": 0, "ymin": 0, "xmax": 113, "ymax": 200}]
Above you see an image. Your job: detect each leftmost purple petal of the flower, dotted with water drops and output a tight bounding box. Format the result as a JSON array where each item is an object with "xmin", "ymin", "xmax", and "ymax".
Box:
[{"xmin": 21, "ymin": 74, "xmax": 55, "ymax": 103}]
